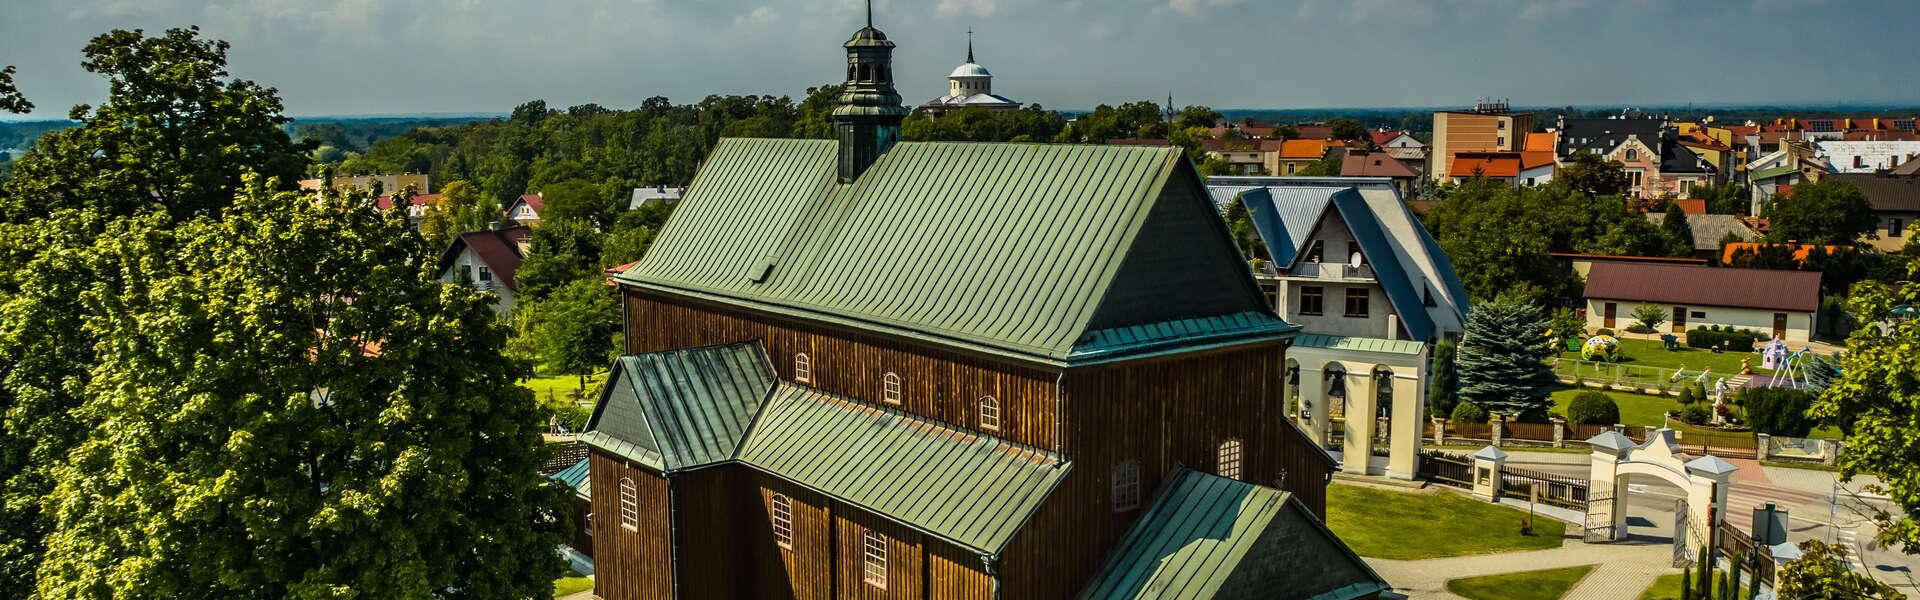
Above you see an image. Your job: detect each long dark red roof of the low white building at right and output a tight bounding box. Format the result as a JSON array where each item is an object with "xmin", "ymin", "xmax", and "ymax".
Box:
[{"xmin": 1586, "ymin": 262, "xmax": 1820, "ymax": 312}]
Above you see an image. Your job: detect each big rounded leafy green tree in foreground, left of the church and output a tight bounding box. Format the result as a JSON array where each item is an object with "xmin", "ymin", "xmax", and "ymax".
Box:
[{"xmin": 38, "ymin": 185, "xmax": 564, "ymax": 598}]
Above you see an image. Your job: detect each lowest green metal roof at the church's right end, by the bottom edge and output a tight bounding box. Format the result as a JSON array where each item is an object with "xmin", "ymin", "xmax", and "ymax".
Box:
[{"xmin": 1079, "ymin": 469, "xmax": 1388, "ymax": 600}]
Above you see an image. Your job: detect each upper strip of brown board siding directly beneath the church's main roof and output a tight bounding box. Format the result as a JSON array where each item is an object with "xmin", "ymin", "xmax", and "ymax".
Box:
[{"xmin": 626, "ymin": 288, "xmax": 1056, "ymax": 450}]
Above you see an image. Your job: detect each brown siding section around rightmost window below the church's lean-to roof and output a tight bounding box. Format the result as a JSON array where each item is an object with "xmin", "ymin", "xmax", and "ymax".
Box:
[{"xmin": 833, "ymin": 508, "xmax": 927, "ymax": 600}]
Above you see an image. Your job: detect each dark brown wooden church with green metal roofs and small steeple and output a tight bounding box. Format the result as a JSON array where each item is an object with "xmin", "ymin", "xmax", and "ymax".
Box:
[{"xmin": 584, "ymin": 7, "xmax": 1386, "ymax": 600}]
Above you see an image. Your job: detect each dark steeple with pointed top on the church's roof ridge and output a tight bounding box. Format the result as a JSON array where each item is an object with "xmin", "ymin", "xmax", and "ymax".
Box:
[{"xmin": 833, "ymin": 0, "xmax": 906, "ymax": 183}]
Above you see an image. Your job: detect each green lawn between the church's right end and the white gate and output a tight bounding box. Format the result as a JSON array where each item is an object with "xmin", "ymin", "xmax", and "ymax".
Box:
[{"xmin": 1327, "ymin": 483, "xmax": 1567, "ymax": 560}]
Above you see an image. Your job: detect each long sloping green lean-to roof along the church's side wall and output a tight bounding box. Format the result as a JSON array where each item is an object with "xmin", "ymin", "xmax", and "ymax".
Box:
[{"xmin": 739, "ymin": 383, "xmax": 1071, "ymax": 554}]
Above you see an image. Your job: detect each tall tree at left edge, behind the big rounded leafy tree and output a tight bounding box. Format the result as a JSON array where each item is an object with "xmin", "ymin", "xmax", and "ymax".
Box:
[{"xmin": 0, "ymin": 29, "xmax": 305, "ymax": 598}]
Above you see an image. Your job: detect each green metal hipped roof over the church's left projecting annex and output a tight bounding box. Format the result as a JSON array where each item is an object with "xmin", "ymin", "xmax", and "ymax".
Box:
[{"xmin": 580, "ymin": 340, "xmax": 774, "ymax": 473}]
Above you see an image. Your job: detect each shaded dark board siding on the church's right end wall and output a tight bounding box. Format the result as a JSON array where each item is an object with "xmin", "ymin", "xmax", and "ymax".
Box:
[{"xmin": 1000, "ymin": 344, "xmax": 1332, "ymax": 598}]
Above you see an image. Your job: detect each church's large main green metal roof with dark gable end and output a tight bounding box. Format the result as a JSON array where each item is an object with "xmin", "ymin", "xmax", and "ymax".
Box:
[{"xmin": 616, "ymin": 138, "xmax": 1284, "ymax": 363}]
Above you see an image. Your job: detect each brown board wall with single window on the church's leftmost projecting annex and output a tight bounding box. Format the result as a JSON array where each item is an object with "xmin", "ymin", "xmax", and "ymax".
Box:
[{"xmin": 588, "ymin": 450, "xmax": 674, "ymax": 600}]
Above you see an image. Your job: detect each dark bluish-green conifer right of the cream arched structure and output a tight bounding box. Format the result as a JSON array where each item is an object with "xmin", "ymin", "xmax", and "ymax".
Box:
[{"xmin": 1455, "ymin": 298, "xmax": 1555, "ymax": 415}]
